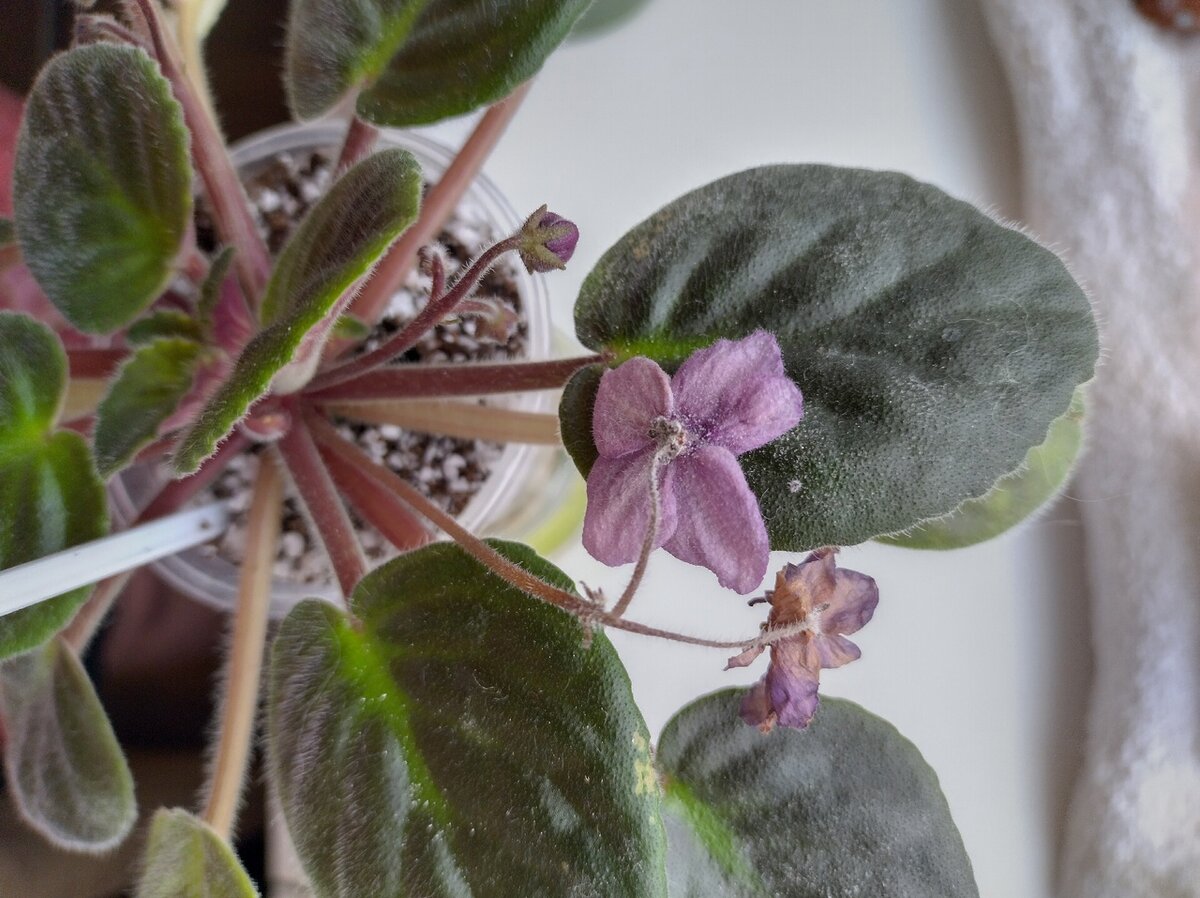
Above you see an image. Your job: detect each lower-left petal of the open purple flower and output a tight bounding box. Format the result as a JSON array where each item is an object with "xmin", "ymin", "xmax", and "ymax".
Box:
[{"xmin": 583, "ymin": 451, "xmax": 676, "ymax": 564}]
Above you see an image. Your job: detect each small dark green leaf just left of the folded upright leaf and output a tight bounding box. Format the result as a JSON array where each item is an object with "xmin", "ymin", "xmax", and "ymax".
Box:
[{"xmin": 95, "ymin": 337, "xmax": 204, "ymax": 479}]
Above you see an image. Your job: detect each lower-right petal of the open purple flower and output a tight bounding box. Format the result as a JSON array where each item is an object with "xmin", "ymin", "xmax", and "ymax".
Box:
[{"xmin": 667, "ymin": 445, "xmax": 770, "ymax": 594}]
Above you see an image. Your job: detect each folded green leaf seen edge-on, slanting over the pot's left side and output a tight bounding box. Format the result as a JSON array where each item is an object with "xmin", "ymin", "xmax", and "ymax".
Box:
[{"xmin": 175, "ymin": 149, "xmax": 421, "ymax": 474}]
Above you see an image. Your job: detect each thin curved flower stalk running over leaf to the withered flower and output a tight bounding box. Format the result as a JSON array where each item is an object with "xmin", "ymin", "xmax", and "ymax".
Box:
[{"xmin": 306, "ymin": 415, "xmax": 777, "ymax": 649}]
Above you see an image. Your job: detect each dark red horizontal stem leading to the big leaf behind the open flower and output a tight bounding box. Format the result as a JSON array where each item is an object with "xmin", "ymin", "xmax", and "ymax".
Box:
[{"xmin": 306, "ymin": 355, "xmax": 606, "ymax": 402}]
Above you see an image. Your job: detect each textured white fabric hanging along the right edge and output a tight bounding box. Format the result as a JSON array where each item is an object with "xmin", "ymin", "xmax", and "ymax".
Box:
[{"xmin": 984, "ymin": 0, "xmax": 1200, "ymax": 898}]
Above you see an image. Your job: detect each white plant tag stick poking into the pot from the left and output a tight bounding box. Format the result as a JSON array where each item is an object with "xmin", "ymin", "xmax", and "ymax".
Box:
[{"xmin": 0, "ymin": 502, "xmax": 229, "ymax": 616}]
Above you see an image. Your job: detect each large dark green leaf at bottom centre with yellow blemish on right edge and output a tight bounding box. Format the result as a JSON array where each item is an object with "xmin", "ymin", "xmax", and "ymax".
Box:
[{"xmin": 268, "ymin": 544, "xmax": 665, "ymax": 898}]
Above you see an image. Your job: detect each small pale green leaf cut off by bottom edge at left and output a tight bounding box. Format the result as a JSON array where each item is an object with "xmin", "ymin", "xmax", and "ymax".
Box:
[{"xmin": 134, "ymin": 808, "xmax": 258, "ymax": 898}]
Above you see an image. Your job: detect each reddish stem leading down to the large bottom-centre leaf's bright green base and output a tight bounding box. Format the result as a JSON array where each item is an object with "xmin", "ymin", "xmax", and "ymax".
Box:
[{"xmin": 277, "ymin": 402, "xmax": 367, "ymax": 598}]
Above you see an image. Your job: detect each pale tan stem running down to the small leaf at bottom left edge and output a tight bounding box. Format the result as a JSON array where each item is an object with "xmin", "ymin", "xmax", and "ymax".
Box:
[{"xmin": 204, "ymin": 453, "xmax": 283, "ymax": 839}]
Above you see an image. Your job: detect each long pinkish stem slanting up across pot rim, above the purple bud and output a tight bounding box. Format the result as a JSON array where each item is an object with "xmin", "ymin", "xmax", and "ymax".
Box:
[{"xmin": 350, "ymin": 84, "xmax": 529, "ymax": 333}]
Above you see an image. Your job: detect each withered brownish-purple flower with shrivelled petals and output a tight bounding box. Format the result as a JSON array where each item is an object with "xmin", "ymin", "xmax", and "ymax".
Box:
[{"xmin": 726, "ymin": 549, "xmax": 880, "ymax": 732}]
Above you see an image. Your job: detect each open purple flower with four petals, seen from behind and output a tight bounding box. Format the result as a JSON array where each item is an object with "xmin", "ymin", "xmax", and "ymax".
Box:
[{"xmin": 583, "ymin": 330, "xmax": 804, "ymax": 593}]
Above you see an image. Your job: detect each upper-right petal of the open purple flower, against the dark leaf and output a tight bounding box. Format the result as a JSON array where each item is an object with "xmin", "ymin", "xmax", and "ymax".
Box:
[{"xmin": 671, "ymin": 330, "xmax": 804, "ymax": 455}]
